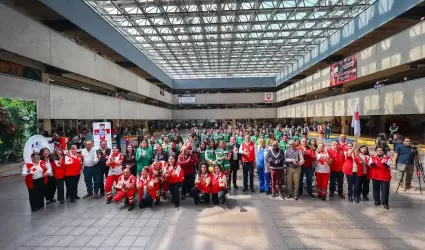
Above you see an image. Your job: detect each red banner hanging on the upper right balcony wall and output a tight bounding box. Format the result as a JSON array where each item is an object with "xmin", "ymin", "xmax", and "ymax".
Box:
[{"xmin": 330, "ymin": 55, "xmax": 357, "ymax": 87}]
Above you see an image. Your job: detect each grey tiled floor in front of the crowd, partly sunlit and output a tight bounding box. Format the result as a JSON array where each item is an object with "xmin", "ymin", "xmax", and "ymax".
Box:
[{"xmin": 0, "ymin": 149, "xmax": 425, "ymax": 250}]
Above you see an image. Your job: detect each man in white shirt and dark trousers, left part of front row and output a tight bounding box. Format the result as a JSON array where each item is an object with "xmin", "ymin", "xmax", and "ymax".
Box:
[{"xmin": 81, "ymin": 141, "xmax": 101, "ymax": 199}]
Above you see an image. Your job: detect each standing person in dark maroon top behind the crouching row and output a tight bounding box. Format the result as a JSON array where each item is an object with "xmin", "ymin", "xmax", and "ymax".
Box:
[{"xmin": 177, "ymin": 146, "xmax": 195, "ymax": 200}]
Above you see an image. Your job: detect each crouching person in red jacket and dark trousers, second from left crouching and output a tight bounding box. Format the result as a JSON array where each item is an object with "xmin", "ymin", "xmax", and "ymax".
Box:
[{"xmin": 137, "ymin": 167, "xmax": 158, "ymax": 208}]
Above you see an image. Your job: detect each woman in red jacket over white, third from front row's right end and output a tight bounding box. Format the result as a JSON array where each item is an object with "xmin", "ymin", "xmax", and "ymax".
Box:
[{"xmin": 342, "ymin": 142, "xmax": 363, "ymax": 203}]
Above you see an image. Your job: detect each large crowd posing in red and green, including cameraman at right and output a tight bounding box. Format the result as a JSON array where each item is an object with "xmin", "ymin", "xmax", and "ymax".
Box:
[{"xmin": 22, "ymin": 125, "xmax": 413, "ymax": 211}]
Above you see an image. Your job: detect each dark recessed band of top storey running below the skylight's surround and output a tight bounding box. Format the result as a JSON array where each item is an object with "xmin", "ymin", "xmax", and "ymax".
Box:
[{"xmin": 3, "ymin": 0, "xmax": 425, "ymax": 93}]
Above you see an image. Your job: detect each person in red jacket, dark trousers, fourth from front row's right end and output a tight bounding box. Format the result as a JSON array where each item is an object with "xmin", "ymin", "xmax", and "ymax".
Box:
[{"xmin": 327, "ymin": 141, "xmax": 345, "ymax": 199}]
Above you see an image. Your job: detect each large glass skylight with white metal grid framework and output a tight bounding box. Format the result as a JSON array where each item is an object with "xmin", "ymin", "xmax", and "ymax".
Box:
[{"xmin": 85, "ymin": 0, "xmax": 376, "ymax": 79}]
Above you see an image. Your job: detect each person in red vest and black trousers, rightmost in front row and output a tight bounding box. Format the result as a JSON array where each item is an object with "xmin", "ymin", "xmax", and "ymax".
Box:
[{"xmin": 369, "ymin": 147, "xmax": 392, "ymax": 209}]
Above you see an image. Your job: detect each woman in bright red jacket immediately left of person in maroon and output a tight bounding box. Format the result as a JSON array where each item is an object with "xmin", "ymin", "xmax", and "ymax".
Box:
[{"xmin": 163, "ymin": 156, "xmax": 184, "ymax": 207}]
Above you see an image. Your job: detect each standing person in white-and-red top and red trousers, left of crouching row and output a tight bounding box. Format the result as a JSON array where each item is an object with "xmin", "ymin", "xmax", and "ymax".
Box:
[{"xmin": 105, "ymin": 146, "xmax": 124, "ymax": 204}]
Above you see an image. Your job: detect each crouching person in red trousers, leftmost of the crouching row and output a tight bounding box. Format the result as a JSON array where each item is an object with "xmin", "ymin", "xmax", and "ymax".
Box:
[{"xmin": 114, "ymin": 168, "xmax": 136, "ymax": 211}]
